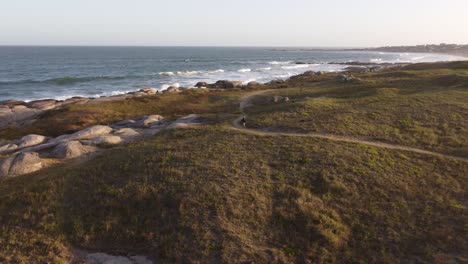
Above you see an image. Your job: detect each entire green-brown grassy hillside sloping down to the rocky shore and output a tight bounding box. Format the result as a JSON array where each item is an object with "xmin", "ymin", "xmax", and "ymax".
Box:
[{"xmin": 0, "ymin": 62, "xmax": 468, "ymax": 263}]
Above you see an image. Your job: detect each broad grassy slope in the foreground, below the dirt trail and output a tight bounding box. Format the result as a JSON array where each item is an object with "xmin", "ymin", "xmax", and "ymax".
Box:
[{"xmin": 0, "ymin": 125, "xmax": 468, "ymax": 263}]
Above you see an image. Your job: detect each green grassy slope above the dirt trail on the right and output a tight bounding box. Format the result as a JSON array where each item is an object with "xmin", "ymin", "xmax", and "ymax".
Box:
[{"xmin": 246, "ymin": 66, "xmax": 468, "ymax": 157}]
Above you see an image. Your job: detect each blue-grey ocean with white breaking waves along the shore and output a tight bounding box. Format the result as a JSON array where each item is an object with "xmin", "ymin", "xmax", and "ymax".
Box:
[{"xmin": 0, "ymin": 46, "xmax": 463, "ymax": 101}]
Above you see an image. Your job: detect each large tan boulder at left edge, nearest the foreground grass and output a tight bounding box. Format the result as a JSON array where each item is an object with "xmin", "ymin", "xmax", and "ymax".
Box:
[{"xmin": 0, "ymin": 152, "xmax": 44, "ymax": 177}]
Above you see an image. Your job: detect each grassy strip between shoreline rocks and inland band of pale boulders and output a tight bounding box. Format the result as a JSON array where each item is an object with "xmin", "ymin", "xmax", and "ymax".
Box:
[{"xmin": 0, "ymin": 89, "xmax": 243, "ymax": 140}]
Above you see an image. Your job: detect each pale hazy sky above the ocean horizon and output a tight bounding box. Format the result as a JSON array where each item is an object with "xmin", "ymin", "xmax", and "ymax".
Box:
[{"xmin": 0, "ymin": 0, "xmax": 468, "ymax": 47}]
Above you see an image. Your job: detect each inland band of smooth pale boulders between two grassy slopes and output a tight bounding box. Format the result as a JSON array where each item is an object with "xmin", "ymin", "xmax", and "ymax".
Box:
[{"xmin": 0, "ymin": 115, "xmax": 200, "ymax": 178}]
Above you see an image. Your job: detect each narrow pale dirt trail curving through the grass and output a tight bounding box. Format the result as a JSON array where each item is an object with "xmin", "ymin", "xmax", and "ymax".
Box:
[{"xmin": 232, "ymin": 89, "xmax": 468, "ymax": 162}]
